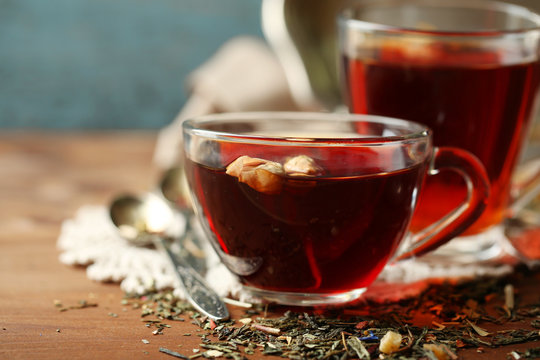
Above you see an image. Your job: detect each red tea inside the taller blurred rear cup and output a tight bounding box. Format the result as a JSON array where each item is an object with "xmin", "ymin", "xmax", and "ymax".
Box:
[{"xmin": 344, "ymin": 47, "xmax": 540, "ymax": 234}]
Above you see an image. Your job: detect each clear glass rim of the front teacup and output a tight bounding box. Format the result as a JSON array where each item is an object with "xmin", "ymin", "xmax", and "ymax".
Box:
[{"xmin": 182, "ymin": 111, "xmax": 432, "ymax": 147}]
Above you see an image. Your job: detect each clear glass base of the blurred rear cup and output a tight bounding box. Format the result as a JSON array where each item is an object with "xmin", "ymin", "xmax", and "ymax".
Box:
[{"xmin": 421, "ymin": 226, "xmax": 507, "ymax": 264}]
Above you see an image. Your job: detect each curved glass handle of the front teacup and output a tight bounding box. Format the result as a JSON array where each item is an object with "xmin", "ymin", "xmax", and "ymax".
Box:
[{"xmin": 396, "ymin": 147, "xmax": 490, "ymax": 260}]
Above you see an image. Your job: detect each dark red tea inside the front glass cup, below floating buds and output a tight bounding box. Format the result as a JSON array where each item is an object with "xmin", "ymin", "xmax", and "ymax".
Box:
[{"xmin": 186, "ymin": 161, "xmax": 424, "ymax": 293}]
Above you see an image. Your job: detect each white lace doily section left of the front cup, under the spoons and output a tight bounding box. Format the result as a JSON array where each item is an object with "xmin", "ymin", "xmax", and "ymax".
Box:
[{"xmin": 57, "ymin": 205, "xmax": 241, "ymax": 298}]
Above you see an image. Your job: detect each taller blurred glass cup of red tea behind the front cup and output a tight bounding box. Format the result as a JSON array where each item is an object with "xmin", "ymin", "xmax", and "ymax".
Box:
[{"xmin": 338, "ymin": 0, "xmax": 540, "ymax": 260}]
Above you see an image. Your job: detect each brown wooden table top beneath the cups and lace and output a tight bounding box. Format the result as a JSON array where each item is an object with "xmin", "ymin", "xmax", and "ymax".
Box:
[{"xmin": 0, "ymin": 132, "xmax": 540, "ymax": 359}]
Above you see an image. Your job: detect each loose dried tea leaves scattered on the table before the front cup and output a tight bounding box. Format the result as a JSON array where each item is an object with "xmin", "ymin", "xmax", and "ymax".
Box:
[{"xmin": 125, "ymin": 266, "xmax": 540, "ymax": 360}]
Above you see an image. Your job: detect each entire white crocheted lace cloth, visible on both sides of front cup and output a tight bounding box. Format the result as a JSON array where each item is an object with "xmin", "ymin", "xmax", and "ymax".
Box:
[{"xmin": 58, "ymin": 205, "xmax": 512, "ymax": 302}]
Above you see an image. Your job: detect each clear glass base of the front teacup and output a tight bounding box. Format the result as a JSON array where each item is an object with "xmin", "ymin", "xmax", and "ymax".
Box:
[{"xmin": 244, "ymin": 285, "xmax": 366, "ymax": 306}]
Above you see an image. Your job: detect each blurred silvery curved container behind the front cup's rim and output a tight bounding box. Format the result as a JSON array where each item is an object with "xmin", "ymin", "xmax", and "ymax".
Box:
[{"xmin": 262, "ymin": 0, "xmax": 348, "ymax": 110}]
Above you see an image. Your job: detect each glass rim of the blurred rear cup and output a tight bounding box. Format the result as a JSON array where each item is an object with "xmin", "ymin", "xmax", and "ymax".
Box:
[{"xmin": 337, "ymin": 0, "xmax": 540, "ymax": 37}]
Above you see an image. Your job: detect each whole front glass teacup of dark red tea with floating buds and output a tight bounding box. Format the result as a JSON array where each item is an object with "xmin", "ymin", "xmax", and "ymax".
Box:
[{"xmin": 183, "ymin": 112, "xmax": 489, "ymax": 305}]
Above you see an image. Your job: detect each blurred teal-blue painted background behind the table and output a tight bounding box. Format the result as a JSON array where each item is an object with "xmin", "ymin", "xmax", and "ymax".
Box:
[{"xmin": 0, "ymin": 0, "xmax": 262, "ymax": 129}]
